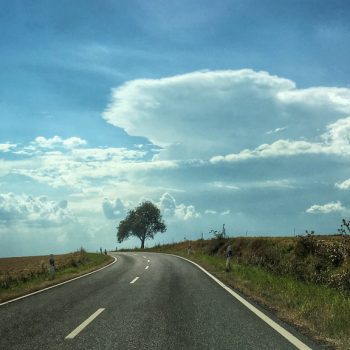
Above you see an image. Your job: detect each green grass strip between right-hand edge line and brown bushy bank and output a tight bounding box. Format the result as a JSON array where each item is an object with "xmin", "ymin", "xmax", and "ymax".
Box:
[{"xmin": 145, "ymin": 241, "xmax": 350, "ymax": 350}]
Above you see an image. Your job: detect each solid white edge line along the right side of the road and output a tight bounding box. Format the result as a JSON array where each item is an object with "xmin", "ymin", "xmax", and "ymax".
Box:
[{"xmin": 167, "ymin": 253, "xmax": 312, "ymax": 350}]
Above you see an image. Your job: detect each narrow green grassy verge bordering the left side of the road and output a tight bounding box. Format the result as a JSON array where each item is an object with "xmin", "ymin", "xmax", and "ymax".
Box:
[{"xmin": 0, "ymin": 253, "xmax": 113, "ymax": 302}]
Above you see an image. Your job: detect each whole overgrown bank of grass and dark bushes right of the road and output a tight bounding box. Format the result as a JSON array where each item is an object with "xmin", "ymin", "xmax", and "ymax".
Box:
[{"xmin": 141, "ymin": 231, "xmax": 350, "ymax": 350}]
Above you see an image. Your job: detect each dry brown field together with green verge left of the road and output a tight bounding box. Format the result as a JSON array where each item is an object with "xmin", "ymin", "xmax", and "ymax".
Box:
[{"xmin": 0, "ymin": 248, "xmax": 113, "ymax": 302}]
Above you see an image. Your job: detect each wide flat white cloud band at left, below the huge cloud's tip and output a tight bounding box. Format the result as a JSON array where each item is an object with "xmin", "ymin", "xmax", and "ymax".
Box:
[{"xmin": 0, "ymin": 136, "xmax": 177, "ymax": 191}]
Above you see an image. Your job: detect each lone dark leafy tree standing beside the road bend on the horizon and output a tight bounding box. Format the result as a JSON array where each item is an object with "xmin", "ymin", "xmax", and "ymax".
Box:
[{"xmin": 117, "ymin": 201, "xmax": 166, "ymax": 248}]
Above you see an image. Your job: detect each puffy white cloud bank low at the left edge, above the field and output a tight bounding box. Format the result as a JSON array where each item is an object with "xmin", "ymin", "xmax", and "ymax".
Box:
[{"xmin": 0, "ymin": 193, "xmax": 74, "ymax": 226}]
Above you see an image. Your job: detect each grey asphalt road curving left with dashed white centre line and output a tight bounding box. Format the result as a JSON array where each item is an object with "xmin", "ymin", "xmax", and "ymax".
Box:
[{"xmin": 0, "ymin": 253, "xmax": 320, "ymax": 350}]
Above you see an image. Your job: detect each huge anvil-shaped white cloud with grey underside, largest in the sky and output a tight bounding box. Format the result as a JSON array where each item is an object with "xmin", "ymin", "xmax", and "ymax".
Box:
[{"xmin": 103, "ymin": 69, "xmax": 350, "ymax": 160}]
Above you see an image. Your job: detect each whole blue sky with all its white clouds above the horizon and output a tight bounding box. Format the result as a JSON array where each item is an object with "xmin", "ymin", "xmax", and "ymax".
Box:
[{"xmin": 0, "ymin": 0, "xmax": 350, "ymax": 257}]
